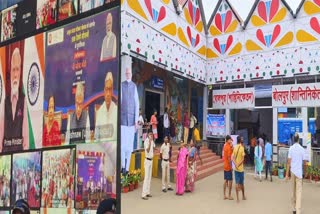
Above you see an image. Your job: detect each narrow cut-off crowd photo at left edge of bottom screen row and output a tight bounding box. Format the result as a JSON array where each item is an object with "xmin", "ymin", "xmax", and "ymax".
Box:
[{"xmin": 0, "ymin": 155, "xmax": 11, "ymax": 208}]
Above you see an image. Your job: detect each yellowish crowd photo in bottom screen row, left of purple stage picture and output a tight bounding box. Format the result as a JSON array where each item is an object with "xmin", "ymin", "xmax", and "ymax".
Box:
[{"xmin": 41, "ymin": 149, "xmax": 74, "ymax": 208}]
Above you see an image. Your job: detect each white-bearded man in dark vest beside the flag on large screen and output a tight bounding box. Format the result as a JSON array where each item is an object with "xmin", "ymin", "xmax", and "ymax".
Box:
[{"xmin": 0, "ymin": 48, "xmax": 29, "ymax": 152}]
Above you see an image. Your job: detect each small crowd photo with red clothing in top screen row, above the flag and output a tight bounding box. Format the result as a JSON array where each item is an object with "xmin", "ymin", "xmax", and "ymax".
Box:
[{"xmin": 36, "ymin": 0, "xmax": 58, "ymax": 29}]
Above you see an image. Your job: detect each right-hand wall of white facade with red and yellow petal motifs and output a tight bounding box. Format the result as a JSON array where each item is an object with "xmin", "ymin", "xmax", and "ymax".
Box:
[{"xmin": 206, "ymin": 0, "xmax": 320, "ymax": 84}]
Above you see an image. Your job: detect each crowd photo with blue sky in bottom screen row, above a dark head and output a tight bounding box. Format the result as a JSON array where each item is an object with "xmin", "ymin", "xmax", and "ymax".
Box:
[{"xmin": 11, "ymin": 152, "xmax": 41, "ymax": 208}]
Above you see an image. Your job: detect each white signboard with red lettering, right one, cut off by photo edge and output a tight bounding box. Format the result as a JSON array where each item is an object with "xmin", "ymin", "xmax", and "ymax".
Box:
[{"xmin": 272, "ymin": 83, "xmax": 320, "ymax": 107}]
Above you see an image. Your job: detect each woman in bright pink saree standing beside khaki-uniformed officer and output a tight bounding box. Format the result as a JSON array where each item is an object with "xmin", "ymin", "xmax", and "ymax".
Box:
[{"xmin": 176, "ymin": 143, "xmax": 188, "ymax": 195}]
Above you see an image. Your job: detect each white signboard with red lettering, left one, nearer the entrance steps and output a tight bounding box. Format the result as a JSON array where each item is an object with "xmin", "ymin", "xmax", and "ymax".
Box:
[{"xmin": 212, "ymin": 88, "xmax": 255, "ymax": 109}]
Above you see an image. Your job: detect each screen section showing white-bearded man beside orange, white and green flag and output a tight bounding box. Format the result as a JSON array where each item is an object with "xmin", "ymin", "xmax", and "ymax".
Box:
[{"xmin": 0, "ymin": 34, "xmax": 44, "ymax": 152}]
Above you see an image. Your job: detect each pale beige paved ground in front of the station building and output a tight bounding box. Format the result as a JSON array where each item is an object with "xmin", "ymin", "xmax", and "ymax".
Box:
[{"xmin": 121, "ymin": 169, "xmax": 320, "ymax": 214}]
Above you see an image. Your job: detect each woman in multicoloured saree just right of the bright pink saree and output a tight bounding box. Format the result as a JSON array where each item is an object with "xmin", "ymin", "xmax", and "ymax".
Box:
[{"xmin": 186, "ymin": 140, "xmax": 198, "ymax": 192}]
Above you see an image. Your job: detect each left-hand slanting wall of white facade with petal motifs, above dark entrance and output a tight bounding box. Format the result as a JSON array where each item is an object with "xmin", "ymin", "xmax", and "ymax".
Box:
[{"xmin": 121, "ymin": 0, "xmax": 206, "ymax": 83}]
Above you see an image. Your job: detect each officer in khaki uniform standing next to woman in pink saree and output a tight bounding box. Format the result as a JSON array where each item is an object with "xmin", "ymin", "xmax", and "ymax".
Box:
[{"xmin": 160, "ymin": 136, "xmax": 173, "ymax": 192}]
